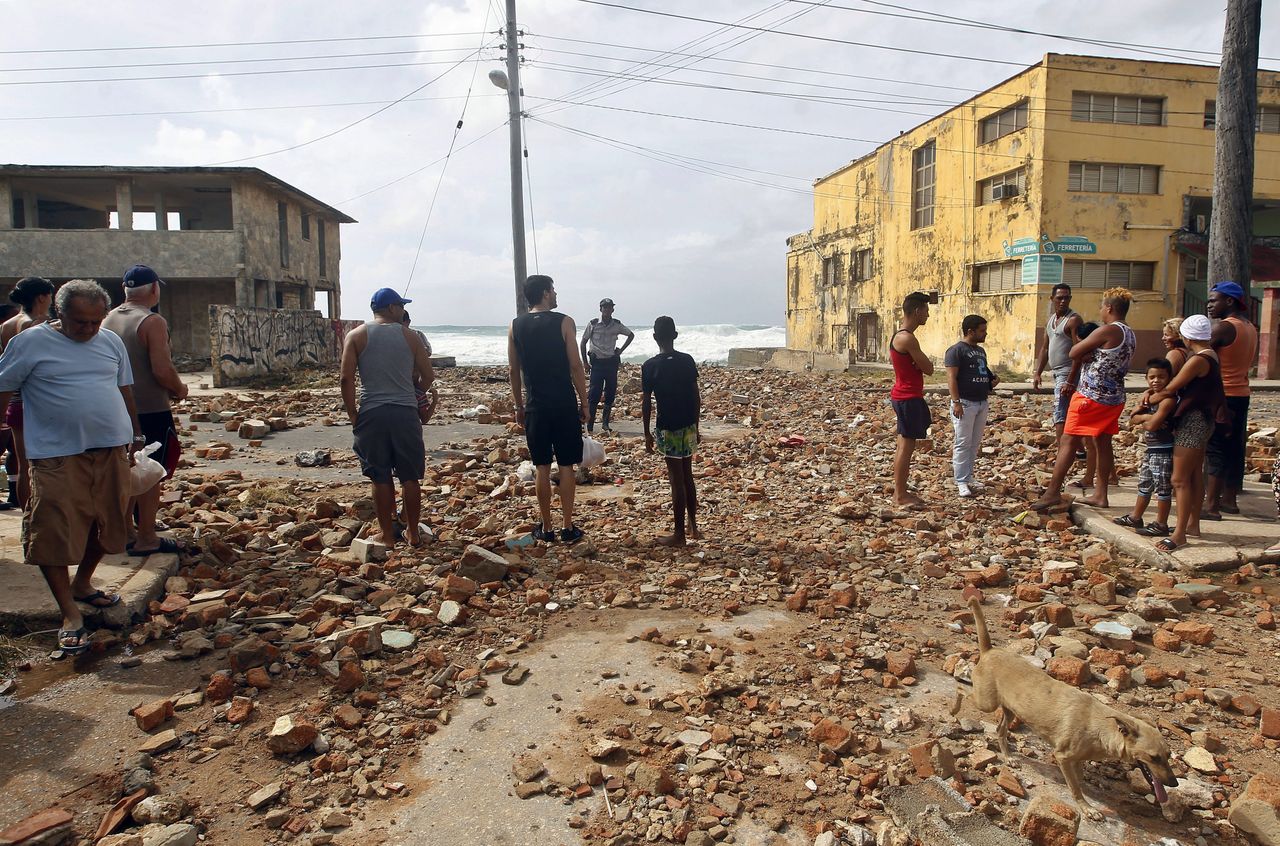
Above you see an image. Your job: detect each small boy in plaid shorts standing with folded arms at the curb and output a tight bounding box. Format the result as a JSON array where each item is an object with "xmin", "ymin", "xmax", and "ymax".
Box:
[{"xmin": 1114, "ymin": 358, "xmax": 1178, "ymax": 538}]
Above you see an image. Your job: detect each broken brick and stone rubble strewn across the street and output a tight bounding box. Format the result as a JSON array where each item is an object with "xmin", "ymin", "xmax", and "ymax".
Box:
[{"xmin": 12, "ymin": 367, "xmax": 1280, "ymax": 846}]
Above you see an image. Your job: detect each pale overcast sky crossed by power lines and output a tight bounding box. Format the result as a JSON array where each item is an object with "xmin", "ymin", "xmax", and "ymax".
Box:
[{"xmin": 0, "ymin": 0, "xmax": 1280, "ymax": 325}]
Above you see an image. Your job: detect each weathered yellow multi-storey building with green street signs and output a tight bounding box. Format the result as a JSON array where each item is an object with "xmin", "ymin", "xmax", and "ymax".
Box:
[{"xmin": 787, "ymin": 54, "xmax": 1280, "ymax": 372}]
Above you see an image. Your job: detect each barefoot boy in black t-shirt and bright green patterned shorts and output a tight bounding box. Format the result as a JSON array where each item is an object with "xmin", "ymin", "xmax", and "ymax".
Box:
[{"xmin": 640, "ymin": 317, "xmax": 703, "ymax": 547}]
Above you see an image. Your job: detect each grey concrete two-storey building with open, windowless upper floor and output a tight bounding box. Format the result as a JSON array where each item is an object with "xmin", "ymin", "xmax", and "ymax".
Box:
[{"xmin": 0, "ymin": 165, "xmax": 355, "ymax": 358}]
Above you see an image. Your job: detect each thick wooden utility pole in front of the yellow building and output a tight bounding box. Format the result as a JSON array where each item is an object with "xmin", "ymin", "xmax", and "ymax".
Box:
[{"xmin": 1208, "ymin": 0, "xmax": 1262, "ymax": 291}]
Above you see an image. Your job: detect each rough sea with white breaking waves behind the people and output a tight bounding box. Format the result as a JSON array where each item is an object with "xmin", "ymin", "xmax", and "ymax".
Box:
[{"xmin": 415, "ymin": 321, "xmax": 787, "ymax": 366}]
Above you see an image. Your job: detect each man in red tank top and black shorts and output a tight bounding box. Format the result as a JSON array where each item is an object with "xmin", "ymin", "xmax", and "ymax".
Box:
[{"xmin": 888, "ymin": 291, "xmax": 933, "ymax": 509}]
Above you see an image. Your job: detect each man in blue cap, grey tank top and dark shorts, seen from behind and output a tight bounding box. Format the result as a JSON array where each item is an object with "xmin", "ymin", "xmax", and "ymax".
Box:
[{"xmin": 342, "ymin": 288, "xmax": 434, "ymax": 547}]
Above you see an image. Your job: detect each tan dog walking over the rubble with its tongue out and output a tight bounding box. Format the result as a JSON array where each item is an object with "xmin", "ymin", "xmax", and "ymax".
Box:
[{"xmin": 951, "ymin": 598, "xmax": 1178, "ymax": 820}]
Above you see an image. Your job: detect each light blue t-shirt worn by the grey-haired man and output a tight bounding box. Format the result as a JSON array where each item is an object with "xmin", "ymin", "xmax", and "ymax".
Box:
[{"xmin": 0, "ymin": 323, "xmax": 133, "ymax": 458}]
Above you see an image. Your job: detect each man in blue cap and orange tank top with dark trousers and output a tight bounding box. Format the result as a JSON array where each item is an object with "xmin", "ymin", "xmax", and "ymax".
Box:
[{"xmin": 1201, "ymin": 282, "xmax": 1258, "ymax": 520}]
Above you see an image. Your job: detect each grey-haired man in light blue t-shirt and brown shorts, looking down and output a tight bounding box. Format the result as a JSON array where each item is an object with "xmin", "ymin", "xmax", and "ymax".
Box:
[{"xmin": 0, "ymin": 279, "xmax": 143, "ymax": 654}]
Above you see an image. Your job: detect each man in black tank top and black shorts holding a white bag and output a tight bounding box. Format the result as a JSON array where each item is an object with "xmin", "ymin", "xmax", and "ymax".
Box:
[{"xmin": 507, "ymin": 275, "xmax": 586, "ymax": 543}]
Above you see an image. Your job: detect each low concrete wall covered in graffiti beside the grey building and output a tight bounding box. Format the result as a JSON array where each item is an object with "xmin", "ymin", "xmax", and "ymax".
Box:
[{"xmin": 209, "ymin": 306, "xmax": 352, "ymax": 387}]
